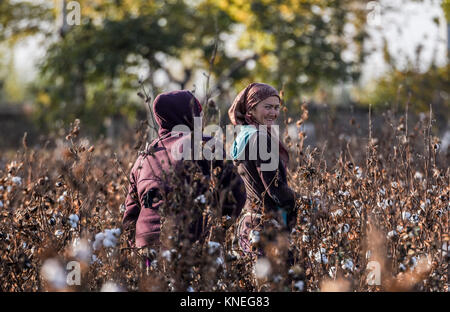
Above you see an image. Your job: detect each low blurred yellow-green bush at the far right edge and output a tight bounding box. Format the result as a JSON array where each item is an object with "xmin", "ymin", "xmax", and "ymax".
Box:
[{"xmin": 361, "ymin": 0, "xmax": 450, "ymax": 124}]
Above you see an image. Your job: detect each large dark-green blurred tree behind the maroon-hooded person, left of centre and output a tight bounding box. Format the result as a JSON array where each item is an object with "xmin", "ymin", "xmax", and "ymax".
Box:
[{"xmin": 34, "ymin": 0, "xmax": 248, "ymax": 130}]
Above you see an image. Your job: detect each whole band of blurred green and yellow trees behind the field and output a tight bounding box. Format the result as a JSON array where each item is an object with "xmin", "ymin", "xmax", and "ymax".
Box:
[{"xmin": 0, "ymin": 0, "xmax": 449, "ymax": 133}]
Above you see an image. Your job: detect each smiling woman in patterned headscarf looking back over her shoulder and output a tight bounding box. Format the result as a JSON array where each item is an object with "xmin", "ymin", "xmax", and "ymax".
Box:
[{"xmin": 228, "ymin": 83, "xmax": 296, "ymax": 256}]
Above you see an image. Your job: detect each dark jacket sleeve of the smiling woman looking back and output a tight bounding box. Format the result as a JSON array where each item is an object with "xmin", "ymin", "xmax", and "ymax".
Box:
[{"xmin": 248, "ymin": 132, "xmax": 295, "ymax": 211}]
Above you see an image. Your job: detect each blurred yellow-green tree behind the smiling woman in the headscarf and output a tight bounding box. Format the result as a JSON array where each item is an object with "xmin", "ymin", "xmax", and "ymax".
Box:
[{"xmin": 216, "ymin": 0, "xmax": 367, "ymax": 109}]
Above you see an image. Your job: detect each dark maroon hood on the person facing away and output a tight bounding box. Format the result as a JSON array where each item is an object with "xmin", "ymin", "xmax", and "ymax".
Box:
[{"xmin": 153, "ymin": 90, "xmax": 202, "ymax": 136}]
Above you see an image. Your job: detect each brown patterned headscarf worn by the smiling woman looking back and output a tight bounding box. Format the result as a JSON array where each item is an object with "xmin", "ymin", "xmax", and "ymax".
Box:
[{"xmin": 228, "ymin": 82, "xmax": 289, "ymax": 167}]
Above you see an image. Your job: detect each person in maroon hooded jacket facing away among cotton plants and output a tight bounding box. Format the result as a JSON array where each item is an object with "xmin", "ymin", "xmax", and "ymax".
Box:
[{"xmin": 122, "ymin": 90, "xmax": 245, "ymax": 248}]
